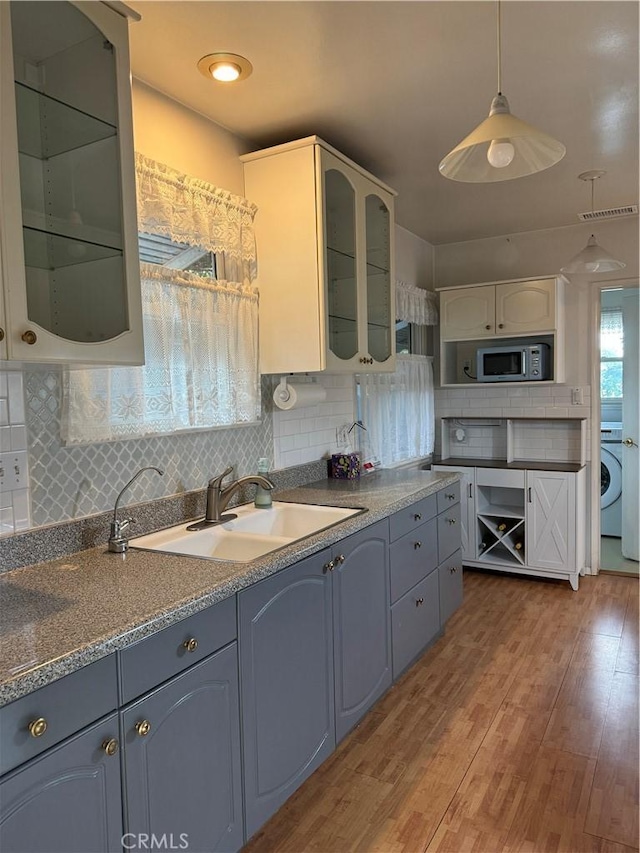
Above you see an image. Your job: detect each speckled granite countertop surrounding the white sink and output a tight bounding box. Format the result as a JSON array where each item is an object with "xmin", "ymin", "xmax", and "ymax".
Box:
[{"xmin": 0, "ymin": 469, "xmax": 458, "ymax": 706}]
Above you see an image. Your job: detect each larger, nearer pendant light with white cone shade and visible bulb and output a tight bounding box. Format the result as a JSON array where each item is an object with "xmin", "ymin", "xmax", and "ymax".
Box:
[{"xmin": 438, "ymin": 0, "xmax": 566, "ymax": 183}]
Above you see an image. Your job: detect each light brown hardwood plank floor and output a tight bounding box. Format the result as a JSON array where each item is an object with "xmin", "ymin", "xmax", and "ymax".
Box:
[{"xmin": 245, "ymin": 571, "xmax": 638, "ymax": 853}]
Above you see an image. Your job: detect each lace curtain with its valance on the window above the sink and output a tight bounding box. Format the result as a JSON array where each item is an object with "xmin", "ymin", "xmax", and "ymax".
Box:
[{"xmin": 61, "ymin": 155, "xmax": 260, "ymax": 444}]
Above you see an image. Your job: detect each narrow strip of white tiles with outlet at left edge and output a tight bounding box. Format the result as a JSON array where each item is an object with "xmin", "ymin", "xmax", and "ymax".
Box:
[{"xmin": 0, "ymin": 372, "xmax": 31, "ymax": 536}]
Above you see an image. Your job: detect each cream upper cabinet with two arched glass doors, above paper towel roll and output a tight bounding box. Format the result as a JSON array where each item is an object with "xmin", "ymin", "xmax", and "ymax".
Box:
[{"xmin": 242, "ymin": 136, "xmax": 395, "ymax": 373}]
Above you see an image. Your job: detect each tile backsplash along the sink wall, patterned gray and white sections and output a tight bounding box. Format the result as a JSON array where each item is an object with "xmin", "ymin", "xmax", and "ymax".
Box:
[{"xmin": 0, "ymin": 367, "xmax": 354, "ymax": 535}]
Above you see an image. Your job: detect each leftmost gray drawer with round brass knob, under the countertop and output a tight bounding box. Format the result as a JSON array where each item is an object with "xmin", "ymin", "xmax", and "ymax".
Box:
[{"xmin": 0, "ymin": 655, "xmax": 118, "ymax": 773}]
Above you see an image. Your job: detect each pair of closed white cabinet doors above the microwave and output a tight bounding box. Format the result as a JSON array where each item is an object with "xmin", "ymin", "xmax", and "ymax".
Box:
[{"xmin": 440, "ymin": 278, "xmax": 559, "ymax": 341}]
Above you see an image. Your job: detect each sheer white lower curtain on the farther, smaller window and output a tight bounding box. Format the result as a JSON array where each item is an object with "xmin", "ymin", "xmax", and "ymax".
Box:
[{"xmin": 359, "ymin": 355, "xmax": 435, "ymax": 467}]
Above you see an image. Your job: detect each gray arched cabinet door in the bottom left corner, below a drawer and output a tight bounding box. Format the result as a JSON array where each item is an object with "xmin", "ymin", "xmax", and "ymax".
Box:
[{"xmin": 0, "ymin": 714, "xmax": 122, "ymax": 853}]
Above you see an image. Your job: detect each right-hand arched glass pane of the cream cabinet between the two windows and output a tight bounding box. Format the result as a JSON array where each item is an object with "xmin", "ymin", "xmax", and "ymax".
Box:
[{"xmin": 365, "ymin": 194, "xmax": 396, "ymax": 364}]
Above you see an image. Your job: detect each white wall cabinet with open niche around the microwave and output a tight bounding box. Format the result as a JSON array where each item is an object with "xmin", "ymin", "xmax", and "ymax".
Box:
[{"xmin": 439, "ymin": 277, "xmax": 564, "ymax": 387}]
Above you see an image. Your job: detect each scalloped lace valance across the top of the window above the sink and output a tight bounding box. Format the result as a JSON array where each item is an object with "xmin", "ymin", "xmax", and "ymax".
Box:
[{"xmin": 136, "ymin": 153, "xmax": 257, "ymax": 281}]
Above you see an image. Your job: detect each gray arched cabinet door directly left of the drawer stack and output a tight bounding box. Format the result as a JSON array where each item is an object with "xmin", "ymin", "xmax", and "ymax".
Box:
[{"xmin": 333, "ymin": 520, "xmax": 391, "ymax": 741}]
